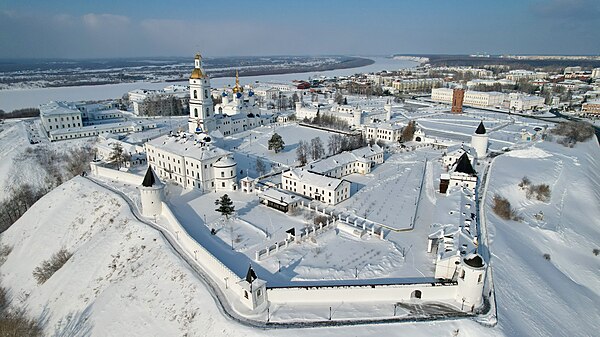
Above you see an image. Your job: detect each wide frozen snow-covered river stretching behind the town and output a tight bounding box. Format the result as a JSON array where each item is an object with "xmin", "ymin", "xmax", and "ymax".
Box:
[{"xmin": 0, "ymin": 56, "xmax": 417, "ymax": 111}]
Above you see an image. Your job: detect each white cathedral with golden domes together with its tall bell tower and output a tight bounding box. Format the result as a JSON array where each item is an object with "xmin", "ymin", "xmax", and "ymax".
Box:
[{"xmin": 188, "ymin": 54, "xmax": 273, "ymax": 136}]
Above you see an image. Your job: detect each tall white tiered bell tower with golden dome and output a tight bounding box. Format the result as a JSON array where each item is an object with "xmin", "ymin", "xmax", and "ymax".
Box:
[{"xmin": 188, "ymin": 54, "xmax": 215, "ymax": 133}]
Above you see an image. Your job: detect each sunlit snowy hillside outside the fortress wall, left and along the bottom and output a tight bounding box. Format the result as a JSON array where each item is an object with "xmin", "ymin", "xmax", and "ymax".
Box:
[{"xmin": 0, "ymin": 177, "xmax": 490, "ymax": 336}]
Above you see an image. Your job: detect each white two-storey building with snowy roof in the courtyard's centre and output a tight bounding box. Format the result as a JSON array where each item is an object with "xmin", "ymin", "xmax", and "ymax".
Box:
[{"xmin": 281, "ymin": 169, "xmax": 350, "ymax": 205}]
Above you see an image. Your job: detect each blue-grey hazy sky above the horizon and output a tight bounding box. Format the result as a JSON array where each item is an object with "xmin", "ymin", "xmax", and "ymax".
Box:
[{"xmin": 0, "ymin": 0, "xmax": 600, "ymax": 58}]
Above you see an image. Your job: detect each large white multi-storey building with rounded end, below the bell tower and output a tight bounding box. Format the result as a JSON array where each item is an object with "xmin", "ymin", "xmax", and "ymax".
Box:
[{"xmin": 144, "ymin": 133, "xmax": 237, "ymax": 191}]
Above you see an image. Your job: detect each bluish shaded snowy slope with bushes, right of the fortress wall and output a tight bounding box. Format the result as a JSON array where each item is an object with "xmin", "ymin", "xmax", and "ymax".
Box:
[{"xmin": 487, "ymin": 139, "xmax": 600, "ymax": 336}]
